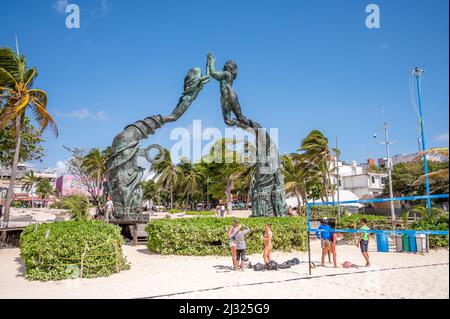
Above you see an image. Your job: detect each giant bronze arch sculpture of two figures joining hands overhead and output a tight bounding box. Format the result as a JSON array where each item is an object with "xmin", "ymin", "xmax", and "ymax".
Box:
[{"xmin": 106, "ymin": 53, "xmax": 287, "ymax": 219}]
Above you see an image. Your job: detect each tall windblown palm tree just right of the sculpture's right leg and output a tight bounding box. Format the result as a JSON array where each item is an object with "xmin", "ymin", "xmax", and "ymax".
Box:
[{"xmin": 299, "ymin": 130, "xmax": 334, "ymax": 202}]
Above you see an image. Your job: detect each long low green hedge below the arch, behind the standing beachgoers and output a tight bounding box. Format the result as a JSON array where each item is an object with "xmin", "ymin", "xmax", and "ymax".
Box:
[{"xmin": 145, "ymin": 217, "xmax": 307, "ymax": 256}]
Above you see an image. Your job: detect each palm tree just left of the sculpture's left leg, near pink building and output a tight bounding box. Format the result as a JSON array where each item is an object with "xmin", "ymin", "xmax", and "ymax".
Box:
[{"xmin": 81, "ymin": 148, "xmax": 109, "ymax": 206}]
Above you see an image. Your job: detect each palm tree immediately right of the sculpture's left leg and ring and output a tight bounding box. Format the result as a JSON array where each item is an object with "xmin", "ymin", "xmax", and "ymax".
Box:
[{"xmin": 152, "ymin": 149, "xmax": 181, "ymax": 209}]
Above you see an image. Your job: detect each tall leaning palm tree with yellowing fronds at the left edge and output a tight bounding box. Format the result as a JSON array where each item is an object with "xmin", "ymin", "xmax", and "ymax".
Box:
[{"xmin": 0, "ymin": 48, "xmax": 58, "ymax": 227}]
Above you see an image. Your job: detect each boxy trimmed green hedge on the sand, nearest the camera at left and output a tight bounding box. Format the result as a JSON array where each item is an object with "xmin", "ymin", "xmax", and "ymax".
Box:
[{"xmin": 20, "ymin": 221, "xmax": 129, "ymax": 281}]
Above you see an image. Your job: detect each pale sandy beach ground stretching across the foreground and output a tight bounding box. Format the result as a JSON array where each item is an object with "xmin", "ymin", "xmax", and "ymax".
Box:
[{"xmin": 0, "ymin": 240, "xmax": 449, "ymax": 299}]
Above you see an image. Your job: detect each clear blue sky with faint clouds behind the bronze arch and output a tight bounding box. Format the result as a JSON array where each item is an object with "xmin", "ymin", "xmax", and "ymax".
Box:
[{"xmin": 0, "ymin": 0, "xmax": 449, "ymax": 171}]
